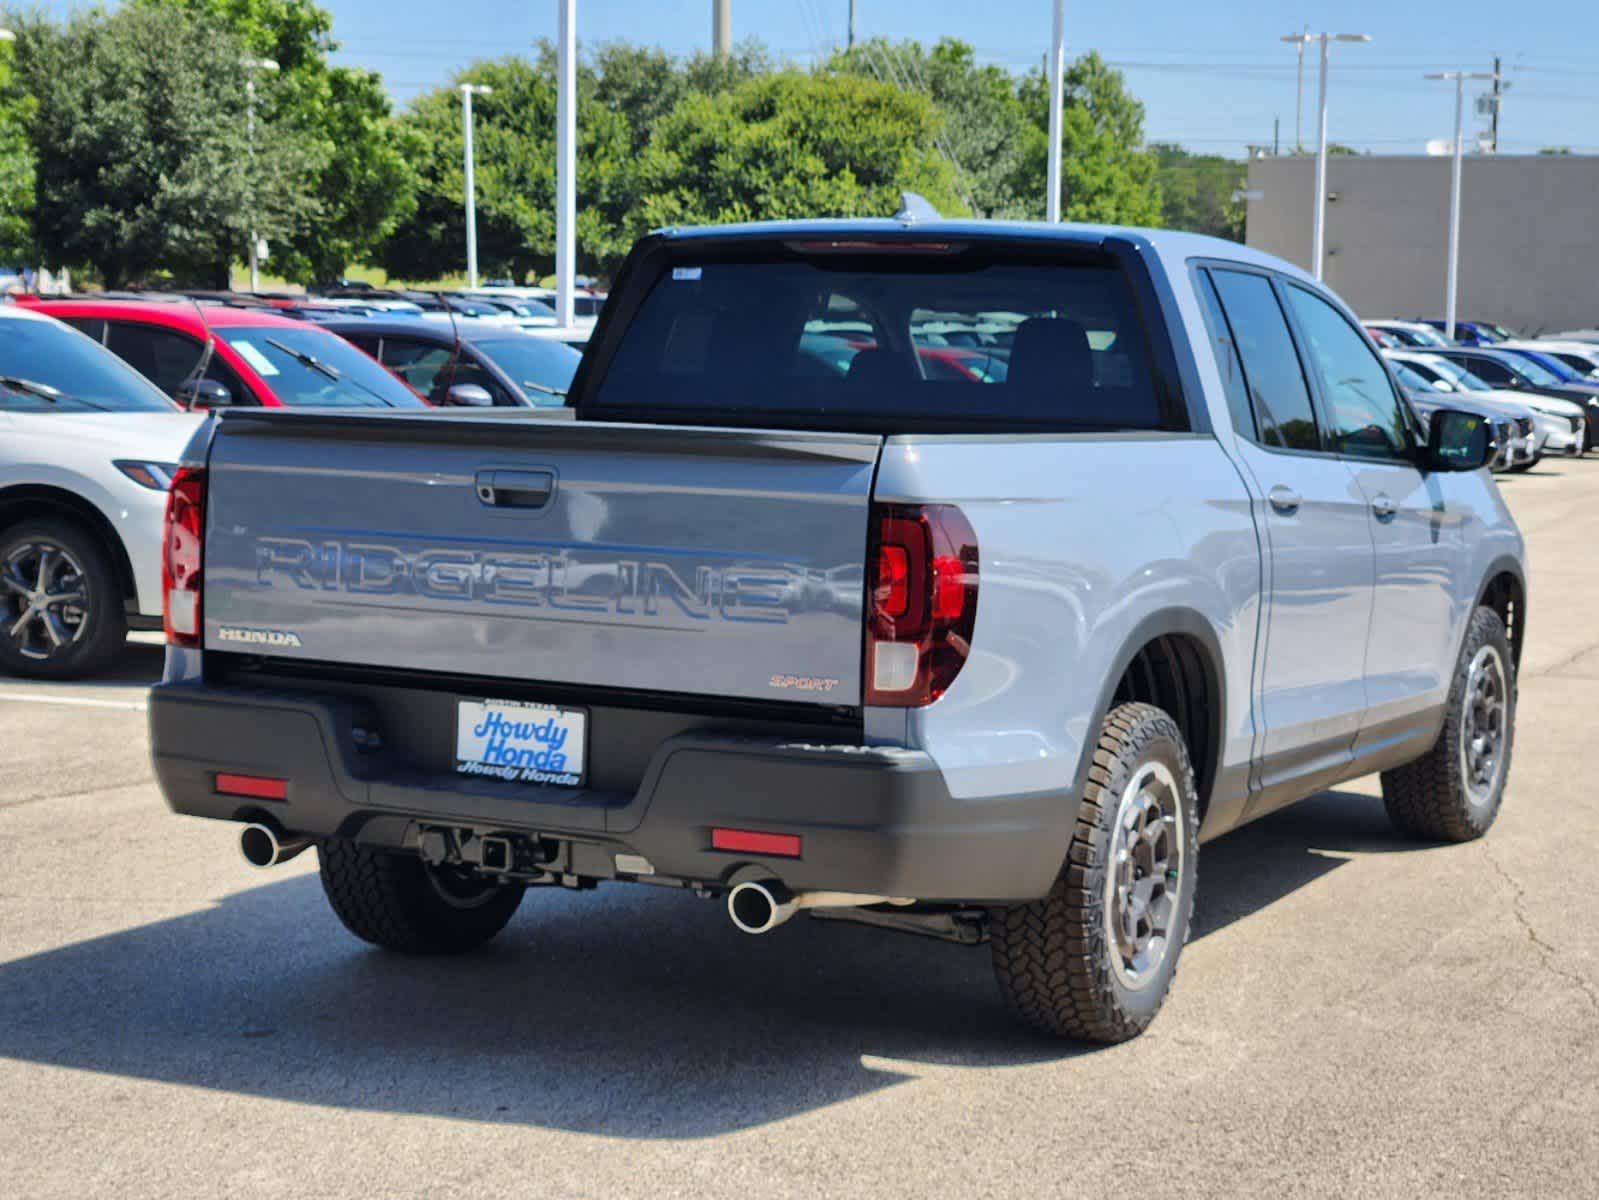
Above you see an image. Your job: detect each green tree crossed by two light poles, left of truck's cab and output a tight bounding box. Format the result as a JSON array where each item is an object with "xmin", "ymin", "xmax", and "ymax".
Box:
[{"xmin": 382, "ymin": 58, "xmax": 630, "ymax": 280}]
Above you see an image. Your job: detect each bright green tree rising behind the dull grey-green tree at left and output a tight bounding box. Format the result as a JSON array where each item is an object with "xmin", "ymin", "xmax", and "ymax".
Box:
[{"xmin": 134, "ymin": 0, "xmax": 421, "ymax": 282}]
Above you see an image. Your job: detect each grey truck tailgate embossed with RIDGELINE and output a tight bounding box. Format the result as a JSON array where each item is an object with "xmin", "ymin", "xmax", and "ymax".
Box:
[{"xmin": 203, "ymin": 411, "xmax": 881, "ymax": 706}]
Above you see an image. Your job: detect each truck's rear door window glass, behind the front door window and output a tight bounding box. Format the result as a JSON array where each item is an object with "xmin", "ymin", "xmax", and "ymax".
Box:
[{"xmin": 1212, "ymin": 270, "xmax": 1321, "ymax": 450}]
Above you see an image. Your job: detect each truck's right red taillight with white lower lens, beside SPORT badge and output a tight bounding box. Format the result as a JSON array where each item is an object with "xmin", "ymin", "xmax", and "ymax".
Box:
[{"xmin": 867, "ymin": 504, "xmax": 977, "ymax": 707}]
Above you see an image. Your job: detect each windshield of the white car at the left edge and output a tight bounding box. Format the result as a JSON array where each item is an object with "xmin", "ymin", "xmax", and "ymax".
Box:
[{"xmin": 0, "ymin": 318, "xmax": 177, "ymax": 413}]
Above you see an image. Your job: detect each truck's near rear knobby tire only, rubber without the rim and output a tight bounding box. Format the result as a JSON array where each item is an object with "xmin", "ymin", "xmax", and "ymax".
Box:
[{"xmin": 990, "ymin": 704, "xmax": 1199, "ymax": 1043}]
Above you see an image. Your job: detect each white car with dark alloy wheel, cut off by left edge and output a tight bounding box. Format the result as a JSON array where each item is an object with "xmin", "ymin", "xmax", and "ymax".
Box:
[{"xmin": 0, "ymin": 304, "xmax": 206, "ymax": 678}]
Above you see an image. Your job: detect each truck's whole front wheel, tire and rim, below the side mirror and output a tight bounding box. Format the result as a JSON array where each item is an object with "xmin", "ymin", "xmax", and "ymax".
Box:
[{"xmin": 1383, "ymin": 608, "xmax": 1516, "ymax": 842}]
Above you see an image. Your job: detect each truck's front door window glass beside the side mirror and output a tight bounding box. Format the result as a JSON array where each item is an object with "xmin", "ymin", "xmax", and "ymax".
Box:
[{"xmin": 1287, "ymin": 285, "xmax": 1415, "ymax": 459}]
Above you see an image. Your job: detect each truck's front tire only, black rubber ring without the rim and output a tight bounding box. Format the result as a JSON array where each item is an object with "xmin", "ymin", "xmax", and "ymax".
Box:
[{"xmin": 1383, "ymin": 608, "xmax": 1516, "ymax": 842}]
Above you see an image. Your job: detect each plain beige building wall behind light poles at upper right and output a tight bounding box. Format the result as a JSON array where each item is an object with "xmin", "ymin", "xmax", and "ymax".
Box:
[{"xmin": 1246, "ymin": 155, "xmax": 1599, "ymax": 333}]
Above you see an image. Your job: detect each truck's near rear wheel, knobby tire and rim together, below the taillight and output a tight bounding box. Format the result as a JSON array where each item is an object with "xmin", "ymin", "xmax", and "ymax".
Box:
[{"xmin": 990, "ymin": 704, "xmax": 1199, "ymax": 1042}]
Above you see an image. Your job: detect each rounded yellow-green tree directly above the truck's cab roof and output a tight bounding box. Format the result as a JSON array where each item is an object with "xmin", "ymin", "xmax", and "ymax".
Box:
[{"xmin": 625, "ymin": 70, "xmax": 964, "ymax": 237}]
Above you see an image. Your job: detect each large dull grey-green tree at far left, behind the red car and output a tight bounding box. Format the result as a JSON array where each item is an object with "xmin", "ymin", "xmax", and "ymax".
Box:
[{"xmin": 18, "ymin": 8, "xmax": 307, "ymax": 286}]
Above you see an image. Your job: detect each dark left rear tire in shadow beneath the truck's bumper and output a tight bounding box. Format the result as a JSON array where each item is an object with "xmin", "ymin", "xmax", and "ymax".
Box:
[{"xmin": 317, "ymin": 838, "xmax": 524, "ymax": 954}]
